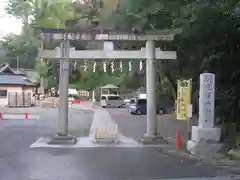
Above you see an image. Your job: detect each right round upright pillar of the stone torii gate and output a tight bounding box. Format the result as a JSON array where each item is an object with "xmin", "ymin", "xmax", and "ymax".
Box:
[{"xmin": 146, "ymin": 41, "xmax": 158, "ymax": 137}]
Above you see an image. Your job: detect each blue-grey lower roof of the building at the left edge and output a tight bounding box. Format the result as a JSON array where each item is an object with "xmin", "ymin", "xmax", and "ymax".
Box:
[{"xmin": 0, "ymin": 74, "xmax": 35, "ymax": 86}]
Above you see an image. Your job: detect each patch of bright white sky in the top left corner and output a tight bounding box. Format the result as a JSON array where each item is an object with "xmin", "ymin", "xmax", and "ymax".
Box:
[{"xmin": 0, "ymin": 0, "xmax": 22, "ymax": 38}]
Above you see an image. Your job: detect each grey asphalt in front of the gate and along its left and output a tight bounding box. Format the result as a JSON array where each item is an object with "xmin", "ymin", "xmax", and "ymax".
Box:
[{"xmin": 0, "ymin": 109, "xmax": 239, "ymax": 180}]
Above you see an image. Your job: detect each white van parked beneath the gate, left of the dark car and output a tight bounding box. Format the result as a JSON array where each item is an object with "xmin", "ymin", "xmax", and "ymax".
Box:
[{"xmin": 100, "ymin": 94, "xmax": 125, "ymax": 108}]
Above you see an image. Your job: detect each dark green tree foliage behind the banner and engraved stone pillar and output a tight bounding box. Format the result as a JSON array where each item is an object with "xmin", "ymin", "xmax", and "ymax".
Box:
[{"xmin": 124, "ymin": 0, "xmax": 240, "ymax": 126}]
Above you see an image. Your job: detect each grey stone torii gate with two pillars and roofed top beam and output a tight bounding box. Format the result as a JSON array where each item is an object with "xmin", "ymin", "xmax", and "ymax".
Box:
[{"xmin": 39, "ymin": 28, "xmax": 178, "ymax": 141}]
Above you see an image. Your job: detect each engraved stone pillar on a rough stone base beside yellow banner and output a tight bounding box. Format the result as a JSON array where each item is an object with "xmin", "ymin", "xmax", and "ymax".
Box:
[{"xmin": 187, "ymin": 73, "xmax": 221, "ymax": 156}]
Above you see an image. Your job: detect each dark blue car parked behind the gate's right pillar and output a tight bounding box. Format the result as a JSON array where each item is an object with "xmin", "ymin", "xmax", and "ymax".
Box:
[{"xmin": 128, "ymin": 99, "xmax": 165, "ymax": 115}]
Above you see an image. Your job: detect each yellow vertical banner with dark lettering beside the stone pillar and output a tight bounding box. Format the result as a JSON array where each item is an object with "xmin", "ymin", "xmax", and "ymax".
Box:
[{"xmin": 176, "ymin": 79, "xmax": 192, "ymax": 120}]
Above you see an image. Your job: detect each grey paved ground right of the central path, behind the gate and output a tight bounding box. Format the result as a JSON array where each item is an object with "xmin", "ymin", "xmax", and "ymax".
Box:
[{"xmin": 108, "ymin": 108, "xmax": 197, "ymax": 143}]
